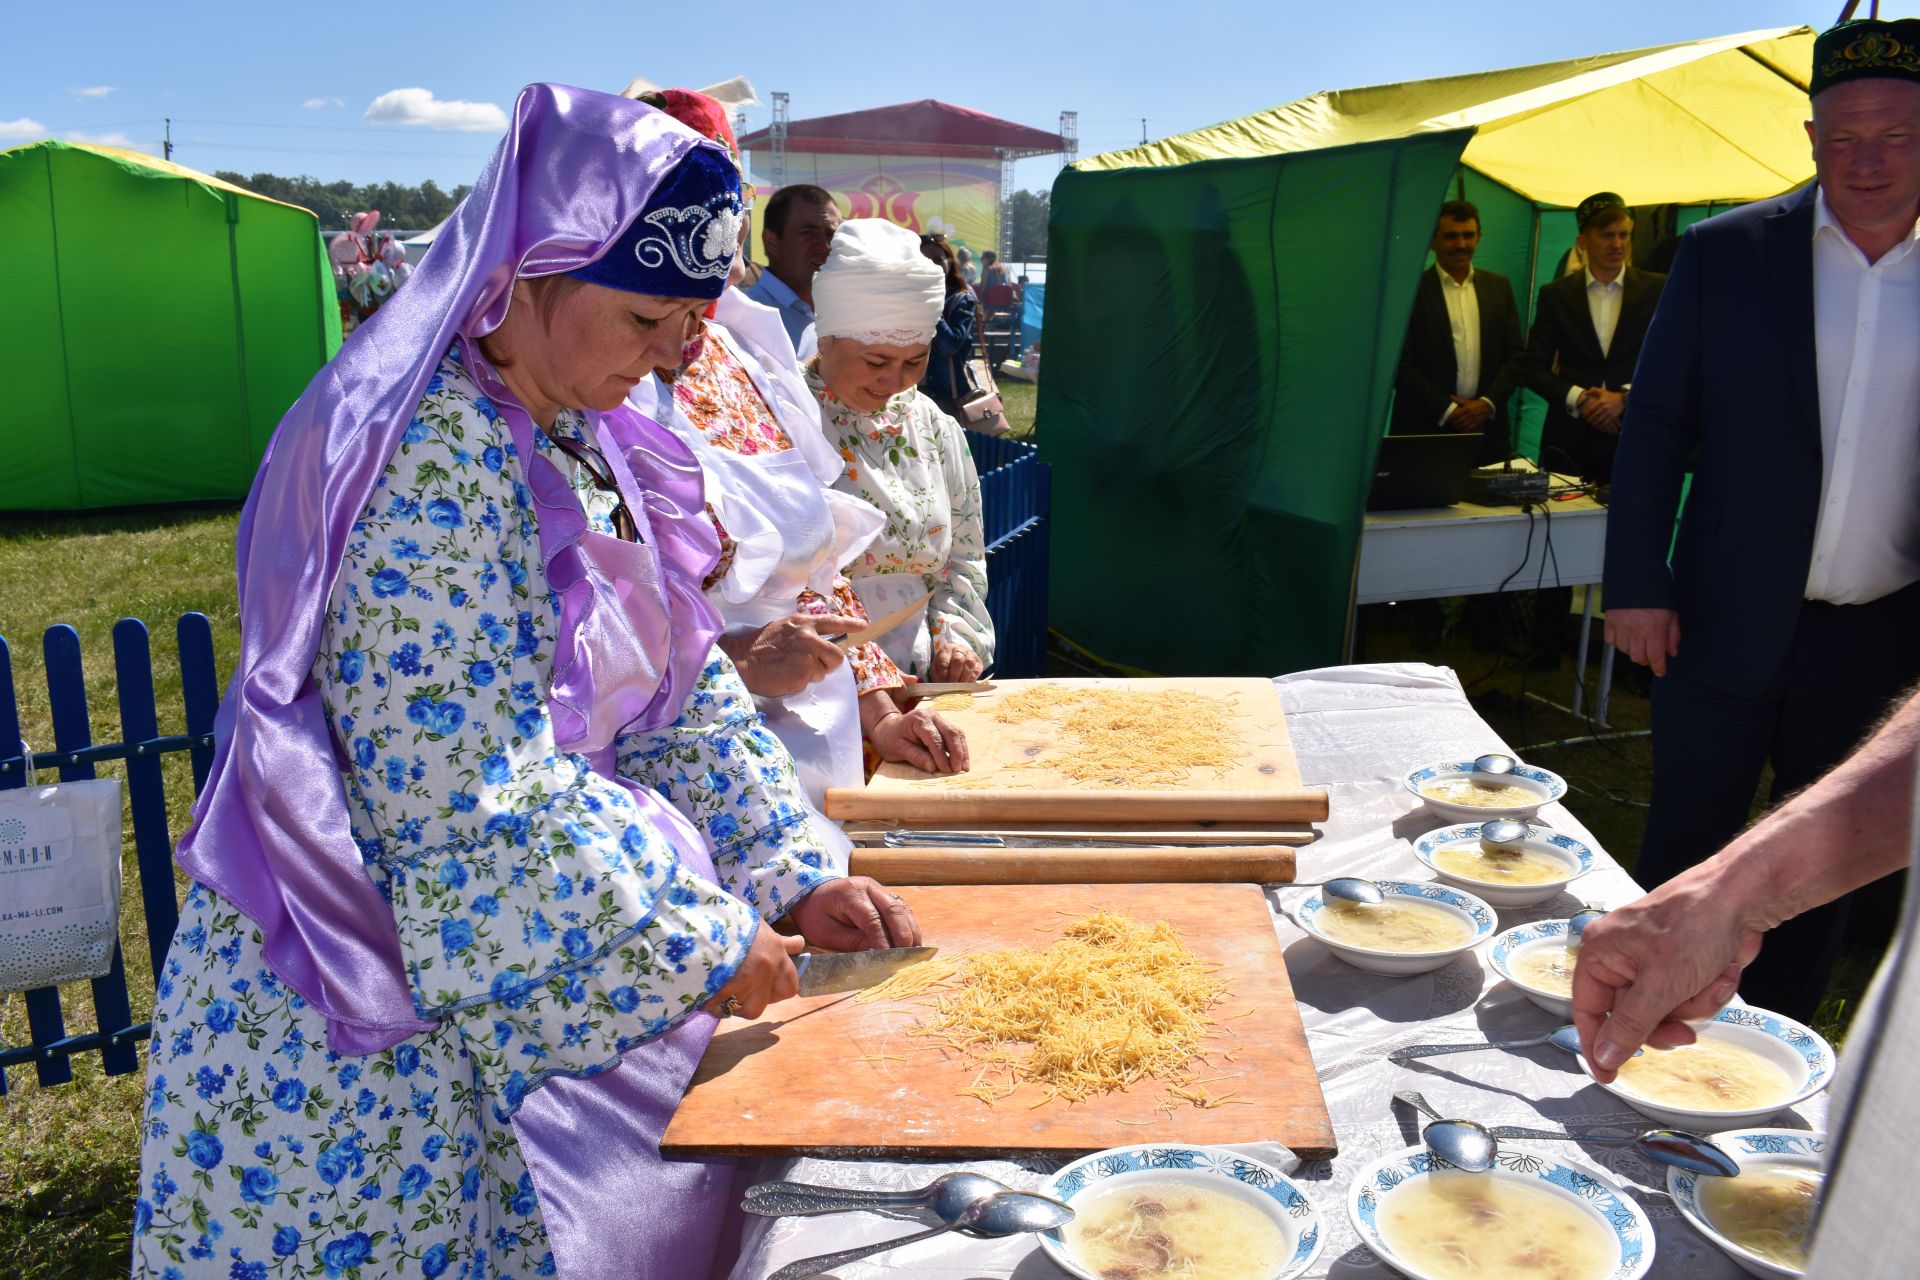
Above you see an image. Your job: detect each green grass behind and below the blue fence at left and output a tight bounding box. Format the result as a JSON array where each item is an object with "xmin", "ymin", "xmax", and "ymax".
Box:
[{"xmin": 0, "ymin": 509, "xmax": 238, "ymax": 1280}]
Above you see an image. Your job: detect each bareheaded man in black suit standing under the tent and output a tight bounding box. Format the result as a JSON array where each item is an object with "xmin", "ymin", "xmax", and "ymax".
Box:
[{"xmin": 1388, "ymin": 200, "xmax": 1521, "ymax": 464}]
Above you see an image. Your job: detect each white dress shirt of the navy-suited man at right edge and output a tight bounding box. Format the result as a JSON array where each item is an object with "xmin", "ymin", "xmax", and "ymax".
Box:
[{"xmin": 1807, "ymin": 192, "xmax": 1920, "ymax": 604}]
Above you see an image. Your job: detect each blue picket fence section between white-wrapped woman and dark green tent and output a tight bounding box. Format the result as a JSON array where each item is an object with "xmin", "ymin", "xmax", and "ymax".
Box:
[{"xmin": 968, "ymin": 432, "xmax": 1050, "ymax": 679}]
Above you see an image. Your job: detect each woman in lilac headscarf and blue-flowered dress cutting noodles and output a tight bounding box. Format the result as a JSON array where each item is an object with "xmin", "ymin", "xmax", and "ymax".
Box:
[{"xmin": 132, "ymin": 84, "xmax": 918, "ymax": 1280}]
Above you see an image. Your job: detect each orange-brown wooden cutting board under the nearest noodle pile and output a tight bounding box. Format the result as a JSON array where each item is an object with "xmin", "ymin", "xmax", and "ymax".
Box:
[{"xmin": 660, "ymin": 885, "xmax": 1334, "ymax": 1159}]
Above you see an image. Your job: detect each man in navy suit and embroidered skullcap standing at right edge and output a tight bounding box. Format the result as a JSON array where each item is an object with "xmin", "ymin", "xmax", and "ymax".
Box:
[{"xmin": 1605, "ymin": 19, "xmax": 1920, "ymax": 1021}]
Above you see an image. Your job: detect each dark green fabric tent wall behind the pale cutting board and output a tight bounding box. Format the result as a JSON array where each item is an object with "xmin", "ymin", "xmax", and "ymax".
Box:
[{"xmin": 1039, "ymin": 130, "xmax": 1469, "ymax": 676}]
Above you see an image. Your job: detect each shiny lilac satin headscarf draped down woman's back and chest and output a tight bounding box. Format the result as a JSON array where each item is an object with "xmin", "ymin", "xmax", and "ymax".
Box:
[{"xmin": 177, "ymin": 84, "xmax": 726, "ymax": 1054}]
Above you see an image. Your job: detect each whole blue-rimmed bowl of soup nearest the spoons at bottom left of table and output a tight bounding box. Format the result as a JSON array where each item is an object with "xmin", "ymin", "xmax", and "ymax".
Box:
[{"xmin": 1041, "ymin": 1142, "xmax": 1327, "ymax": 1280}]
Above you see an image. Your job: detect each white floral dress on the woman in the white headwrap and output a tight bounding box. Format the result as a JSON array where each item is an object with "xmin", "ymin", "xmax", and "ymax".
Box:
[{"xmin": 806, "ymin": 367, "xmax": 993, "ymax": 677}]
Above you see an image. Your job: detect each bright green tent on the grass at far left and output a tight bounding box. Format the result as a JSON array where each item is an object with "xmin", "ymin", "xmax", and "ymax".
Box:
[{"xmin": 0, "ymin": 142, "xmax": 340, "ymax": 510}]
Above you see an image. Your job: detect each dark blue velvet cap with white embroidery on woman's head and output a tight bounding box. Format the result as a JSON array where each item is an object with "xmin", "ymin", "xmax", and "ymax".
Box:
[{"xmin": 572, "ymin": 146, "xmax": 743, "ymax": 297}]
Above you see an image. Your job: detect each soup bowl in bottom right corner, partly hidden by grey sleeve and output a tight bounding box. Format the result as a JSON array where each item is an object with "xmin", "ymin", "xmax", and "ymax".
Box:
[{"xmin": 1667, "ymin": 1128, "xmax": 1826, "ymax": 1280}]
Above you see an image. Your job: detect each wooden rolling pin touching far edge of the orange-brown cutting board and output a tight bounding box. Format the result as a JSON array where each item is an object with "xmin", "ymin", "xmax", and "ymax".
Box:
[{"xmin": 849, "ymin": 846, "xmax": 1294, "ymax": 885}]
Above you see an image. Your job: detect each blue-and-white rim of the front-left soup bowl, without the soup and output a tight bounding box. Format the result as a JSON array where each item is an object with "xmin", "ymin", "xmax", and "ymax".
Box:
[{"xmin": 1041, "ymin": 1142, "xmax": 1327, "ymax": 1280}]
